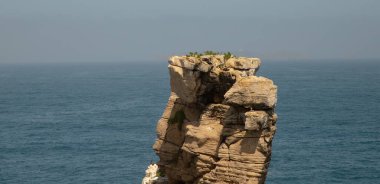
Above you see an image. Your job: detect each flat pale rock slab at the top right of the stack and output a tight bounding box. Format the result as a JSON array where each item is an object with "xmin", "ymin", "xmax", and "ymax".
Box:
[{"xmin": 226, "ymin": 57, "xmax": 261, "ymax": 70}]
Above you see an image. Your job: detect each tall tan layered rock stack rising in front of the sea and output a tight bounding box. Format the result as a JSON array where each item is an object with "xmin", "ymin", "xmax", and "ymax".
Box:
[{"xmin": 153, "ymin": 55, "xmax": 277, "ymax": 184}]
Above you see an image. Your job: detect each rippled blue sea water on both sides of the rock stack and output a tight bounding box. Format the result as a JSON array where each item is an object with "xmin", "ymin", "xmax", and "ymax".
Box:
[{"xmin": 0, "ymin": 61, "xmax": 380, "ymax": 184}]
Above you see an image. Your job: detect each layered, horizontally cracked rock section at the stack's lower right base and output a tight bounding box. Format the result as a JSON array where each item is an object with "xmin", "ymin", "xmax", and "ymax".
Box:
[{"xmin": 200, "ymin": 138, "xmax": 269, "ymax": 184}]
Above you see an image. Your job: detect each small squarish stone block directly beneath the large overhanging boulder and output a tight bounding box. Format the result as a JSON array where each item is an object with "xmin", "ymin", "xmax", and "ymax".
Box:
[{"xmin": 244, "ymin": 111, "xmax": 268, "ymax": 131}]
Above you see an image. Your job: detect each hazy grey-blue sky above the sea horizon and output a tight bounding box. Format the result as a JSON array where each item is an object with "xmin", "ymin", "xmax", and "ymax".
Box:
[{"xmin": 0, "ymin": 0, "xmax": 380, "ymax": 62}]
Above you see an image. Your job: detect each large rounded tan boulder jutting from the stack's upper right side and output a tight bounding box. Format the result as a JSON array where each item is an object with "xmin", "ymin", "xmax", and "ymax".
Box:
[{"xmin": 224, "ymin": 76, "xmax": 277, "ymax": 109}]
